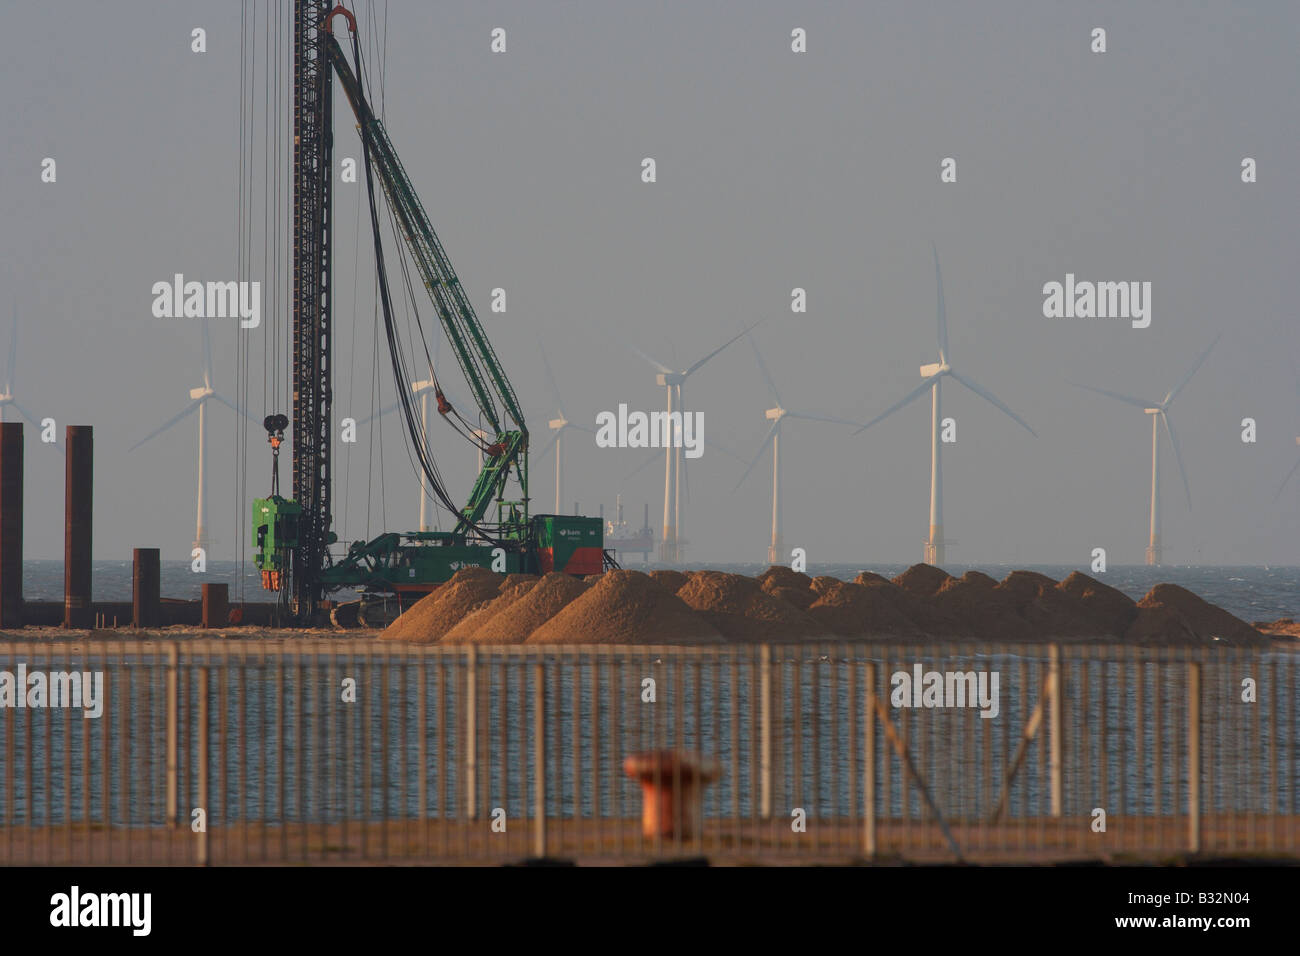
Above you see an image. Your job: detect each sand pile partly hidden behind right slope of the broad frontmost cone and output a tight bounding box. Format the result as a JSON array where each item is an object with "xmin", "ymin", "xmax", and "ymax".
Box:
[{"xmin": 677, "ymin": 571, "xmax": 824, "ymax": 641}]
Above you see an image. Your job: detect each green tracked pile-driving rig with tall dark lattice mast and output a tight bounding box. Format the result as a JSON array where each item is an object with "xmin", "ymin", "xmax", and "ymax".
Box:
[{"xmin": 252, "ymin": 0, "xmax": 612, "ymax": 622}]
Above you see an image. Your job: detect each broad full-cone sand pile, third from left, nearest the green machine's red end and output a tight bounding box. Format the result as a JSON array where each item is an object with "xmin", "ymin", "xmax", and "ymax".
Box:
[{"xmin": 528, "ymin": 571, "xmax": 723, "ymax": 644}]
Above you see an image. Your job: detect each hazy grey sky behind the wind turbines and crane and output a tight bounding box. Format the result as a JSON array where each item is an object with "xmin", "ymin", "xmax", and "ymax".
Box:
[{"xmin": 0, "ymin": 0, "xmax": 1300, "ymax": 564}]
